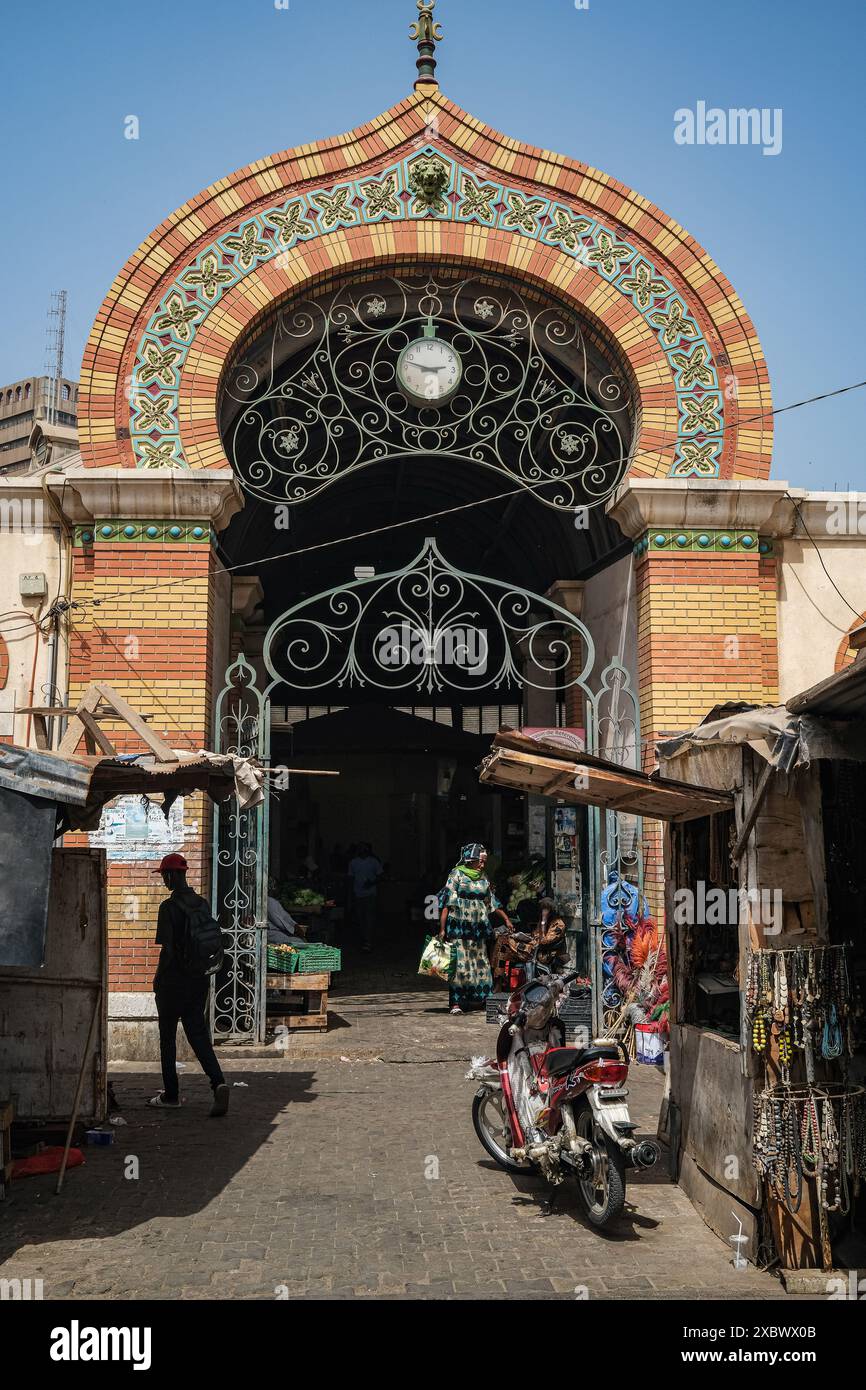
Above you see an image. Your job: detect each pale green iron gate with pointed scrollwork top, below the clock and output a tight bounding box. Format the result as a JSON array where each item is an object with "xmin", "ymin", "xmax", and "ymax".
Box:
[{"xmin": 213, "ymin": 538, "xmax": 639, "ymax": 1041}]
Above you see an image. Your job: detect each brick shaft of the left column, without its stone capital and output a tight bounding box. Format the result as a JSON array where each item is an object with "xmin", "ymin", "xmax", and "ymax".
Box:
[{"xmin": 70, "ymin": 520, "xmax": 215, "ymax": 992}]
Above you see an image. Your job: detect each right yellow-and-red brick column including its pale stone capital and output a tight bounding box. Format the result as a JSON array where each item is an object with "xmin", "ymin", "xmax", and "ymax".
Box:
[{"xmin": 609, "ymin": 480, "xmax": 785, "ymax": 915}]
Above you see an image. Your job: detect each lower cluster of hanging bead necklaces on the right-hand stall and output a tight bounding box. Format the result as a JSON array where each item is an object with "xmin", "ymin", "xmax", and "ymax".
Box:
[{"xmin": 753, "ymin": 1081, "xmax": 866, "ymax": 1213}]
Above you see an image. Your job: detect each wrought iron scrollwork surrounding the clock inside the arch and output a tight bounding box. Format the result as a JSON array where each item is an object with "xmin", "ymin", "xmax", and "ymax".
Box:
[{"xmin": 222, "ymin": 275, "xmax": 631, "ymax": 509}]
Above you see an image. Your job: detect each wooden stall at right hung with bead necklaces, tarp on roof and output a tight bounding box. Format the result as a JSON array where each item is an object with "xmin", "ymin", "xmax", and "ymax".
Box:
[{"xmin": 659, "ymin": 659, "xmax": 866, "ymax": 1270}]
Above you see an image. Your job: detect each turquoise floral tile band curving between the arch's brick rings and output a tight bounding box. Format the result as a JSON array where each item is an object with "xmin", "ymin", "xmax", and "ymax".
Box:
[{"xmin": 128, "ymin": 145, "xmax": 724, "ymax": 478}]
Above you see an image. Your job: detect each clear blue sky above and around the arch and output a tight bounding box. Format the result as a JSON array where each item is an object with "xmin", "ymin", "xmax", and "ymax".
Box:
[{"xmin": 0, "ymin": 0, "xmax": 866, "ymax": 489}]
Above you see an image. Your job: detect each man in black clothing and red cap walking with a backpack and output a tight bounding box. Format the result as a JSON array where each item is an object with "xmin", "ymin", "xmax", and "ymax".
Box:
[{"xmin": 147, "ymin": 855, "xmax": 228, "ymax": 1116}]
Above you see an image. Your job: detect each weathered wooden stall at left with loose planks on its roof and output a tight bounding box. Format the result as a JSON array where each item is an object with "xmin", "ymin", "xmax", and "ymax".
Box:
[{"xmin": 0, "ymin": 685, "xmax": 264, "ymax": 1195}]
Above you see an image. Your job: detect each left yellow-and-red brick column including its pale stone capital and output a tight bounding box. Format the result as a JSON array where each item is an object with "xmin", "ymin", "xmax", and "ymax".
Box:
[{"xmin": 67, "ymin": 470, "xmax": 239, "ymax": 1016}]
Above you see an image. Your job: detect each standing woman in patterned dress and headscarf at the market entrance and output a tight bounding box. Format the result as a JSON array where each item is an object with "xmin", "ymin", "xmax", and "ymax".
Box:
[{"xmin": 439, "ymin": 844, "xmax": 513, "ymax": 1013}]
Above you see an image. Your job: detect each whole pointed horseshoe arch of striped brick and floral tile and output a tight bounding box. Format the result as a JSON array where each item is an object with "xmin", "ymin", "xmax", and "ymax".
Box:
[{"xmin": 81, "ymin": 88, "xmax": 770, "ymax": 489}]
